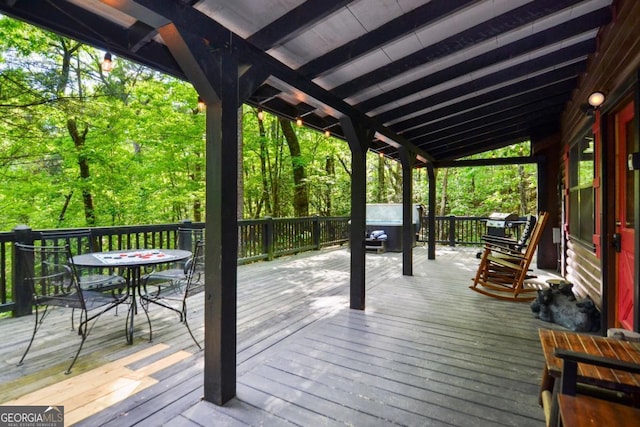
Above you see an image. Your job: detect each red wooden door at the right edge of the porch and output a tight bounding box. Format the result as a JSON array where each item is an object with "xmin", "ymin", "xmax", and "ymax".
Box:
[{"xmin": 614, "ymin": 102, "xmax": 637, "ymax": 330}]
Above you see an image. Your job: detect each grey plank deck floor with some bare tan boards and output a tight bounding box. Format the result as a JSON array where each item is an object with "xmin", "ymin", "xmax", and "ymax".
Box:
[{"xmin": 0, "ymin": 247, "xmax": 554, "ymax": 427}]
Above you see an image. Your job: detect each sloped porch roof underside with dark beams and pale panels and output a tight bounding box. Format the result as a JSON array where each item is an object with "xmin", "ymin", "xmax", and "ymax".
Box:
[{"xmin": 0, "ymin": 0, "xmax": 612, "ymax": 165}]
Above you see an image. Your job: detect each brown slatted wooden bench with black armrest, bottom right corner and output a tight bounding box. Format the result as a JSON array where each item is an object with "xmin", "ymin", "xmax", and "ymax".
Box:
[{"xmin": 538, "ymin": 329, "xmax": 640, "ymax": 426}]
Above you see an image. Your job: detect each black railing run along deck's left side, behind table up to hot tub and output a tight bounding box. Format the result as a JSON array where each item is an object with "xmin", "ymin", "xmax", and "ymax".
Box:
[{"xmin": 0, "ymin": 216, "xmax": 349, "ymax": 315}]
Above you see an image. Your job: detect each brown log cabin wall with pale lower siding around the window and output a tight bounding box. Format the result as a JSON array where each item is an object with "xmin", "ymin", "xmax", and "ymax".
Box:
[{"xmin": 559, "ymin": 0, "xmax": 640, "ymax": 310}]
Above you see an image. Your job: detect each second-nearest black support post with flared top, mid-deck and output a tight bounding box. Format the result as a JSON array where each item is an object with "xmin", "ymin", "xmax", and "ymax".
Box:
[{"xmin": 340, "ymin": 117, "xmax": 374, "ymax": 310}]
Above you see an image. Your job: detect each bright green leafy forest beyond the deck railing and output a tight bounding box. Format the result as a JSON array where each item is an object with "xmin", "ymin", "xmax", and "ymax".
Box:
[{"xmin": 0, "ymin": 15, "xmax": 536, "ymax": 231}]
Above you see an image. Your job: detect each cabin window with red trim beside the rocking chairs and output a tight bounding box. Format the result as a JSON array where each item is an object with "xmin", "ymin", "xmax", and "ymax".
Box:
[{"xmin": 569, "ymin": 133, "xmax": 595, "ymax": 247}]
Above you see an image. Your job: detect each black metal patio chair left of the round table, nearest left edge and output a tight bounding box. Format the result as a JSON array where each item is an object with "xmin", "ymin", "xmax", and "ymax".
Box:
[{"xmin": 14, "ymin": 243, "xmax": 128, "ymax": 374}]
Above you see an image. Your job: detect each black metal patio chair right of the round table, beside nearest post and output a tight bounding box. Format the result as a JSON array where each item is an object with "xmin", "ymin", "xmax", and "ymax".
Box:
[{"xmin": 140, "ymin": 240, "xmax": 204, "ymax": 349}]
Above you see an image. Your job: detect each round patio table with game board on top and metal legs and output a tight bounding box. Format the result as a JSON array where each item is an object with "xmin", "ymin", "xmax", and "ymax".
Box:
[{"xmin": 73, "ymin": 249, "xmax": 192, "ymax": 344}]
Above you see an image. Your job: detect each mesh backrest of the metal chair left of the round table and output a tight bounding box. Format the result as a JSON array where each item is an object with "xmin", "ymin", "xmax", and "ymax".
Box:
[{"xmin": 14, "ymin": 243, "xmax": 85, "ymax": 308}]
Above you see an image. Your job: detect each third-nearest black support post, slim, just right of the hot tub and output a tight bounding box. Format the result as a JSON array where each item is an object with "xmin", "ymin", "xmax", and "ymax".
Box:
[{"xmin": 399, "ymin": 147, "xmax": 416, "ymax": 276}]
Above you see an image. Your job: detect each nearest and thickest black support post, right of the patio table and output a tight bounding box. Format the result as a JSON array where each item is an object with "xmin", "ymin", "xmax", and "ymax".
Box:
[{"xmin": 204, "ymin": 52, "xmax": 238, "ymax": 405}]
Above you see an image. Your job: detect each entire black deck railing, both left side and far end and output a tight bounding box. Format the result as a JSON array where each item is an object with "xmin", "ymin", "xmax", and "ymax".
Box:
[{"xmin": 0, "ymin": 216, "xmax": 521, "ymax": 315}]
